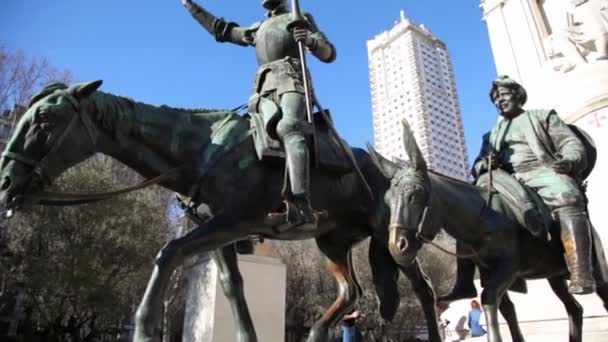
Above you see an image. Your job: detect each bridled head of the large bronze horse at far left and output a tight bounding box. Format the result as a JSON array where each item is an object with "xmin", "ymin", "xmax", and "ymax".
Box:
[{"xmin": 0, "ymin": 81, "xmax": 101, "ymax": 209}]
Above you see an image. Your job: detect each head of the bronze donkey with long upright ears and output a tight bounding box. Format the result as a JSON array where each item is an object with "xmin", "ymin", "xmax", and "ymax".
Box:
[{"xmin": 370, "ymin": 121, "xmax": 430, "ymax": 264}]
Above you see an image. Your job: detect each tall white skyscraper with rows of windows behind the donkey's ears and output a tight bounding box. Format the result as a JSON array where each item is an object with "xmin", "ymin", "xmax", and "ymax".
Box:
[{"xmin": 367, "ymin": 11, "xmax": 469, "ymax": 179}]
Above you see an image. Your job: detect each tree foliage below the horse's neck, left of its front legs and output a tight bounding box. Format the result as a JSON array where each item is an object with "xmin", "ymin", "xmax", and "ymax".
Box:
[{"xmin": 0, "ymin": 157, "xmax": 171, "ymax": 341}]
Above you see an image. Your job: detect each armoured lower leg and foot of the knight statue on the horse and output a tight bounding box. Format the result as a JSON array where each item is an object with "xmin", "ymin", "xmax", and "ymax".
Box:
[{"xmin": 266, "ymin": 132, "xmax": 319, "ymax": 231}]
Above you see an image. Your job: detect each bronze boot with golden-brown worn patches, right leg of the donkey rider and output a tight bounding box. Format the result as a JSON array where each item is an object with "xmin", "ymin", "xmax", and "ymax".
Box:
[{"xmin": 555, "ymin": 207, "xmax": 595, "ymax": 294}]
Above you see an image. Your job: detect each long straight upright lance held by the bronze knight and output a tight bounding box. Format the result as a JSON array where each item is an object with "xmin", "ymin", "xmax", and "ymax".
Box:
[{"xmin": 288, "ymin": 0, "xmax": 319, "ymax": 167}]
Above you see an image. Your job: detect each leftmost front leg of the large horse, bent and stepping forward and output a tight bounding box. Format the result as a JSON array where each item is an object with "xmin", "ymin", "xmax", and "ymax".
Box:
[{"xmin": 133, "ymin": 215, "xmax": 243, "ymax": 342}]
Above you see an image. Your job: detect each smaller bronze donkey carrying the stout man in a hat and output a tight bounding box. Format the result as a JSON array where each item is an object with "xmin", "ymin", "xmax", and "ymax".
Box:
[{"xmin": 371, "ymin": 122, "xmax": 608, "ymax": 342}]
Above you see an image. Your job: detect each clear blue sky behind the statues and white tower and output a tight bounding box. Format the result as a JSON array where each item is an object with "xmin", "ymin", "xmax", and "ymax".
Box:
[{"xmin": 0, "ymin": 0, "xmax": 496, "ymax": 166}]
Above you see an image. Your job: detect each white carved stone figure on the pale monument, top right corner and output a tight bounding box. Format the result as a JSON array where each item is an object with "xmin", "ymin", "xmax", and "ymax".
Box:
[{"xmin": 548, "ymin": 0, "xmax": 608, "ymax": 72}]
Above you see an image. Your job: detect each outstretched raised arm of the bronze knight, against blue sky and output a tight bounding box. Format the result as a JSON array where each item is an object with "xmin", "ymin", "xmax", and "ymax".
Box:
[{"xmin": 182, "ymin": 0, "xmax": 253, "ymax": 46}]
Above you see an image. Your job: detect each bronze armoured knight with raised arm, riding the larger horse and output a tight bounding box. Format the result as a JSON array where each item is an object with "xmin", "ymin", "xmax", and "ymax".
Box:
[{"xmin": 182, "ymin": 0, "xmax": 336, "ymax": 230}]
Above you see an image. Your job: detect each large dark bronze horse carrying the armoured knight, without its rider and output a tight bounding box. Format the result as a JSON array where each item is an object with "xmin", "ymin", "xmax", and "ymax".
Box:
[{"xmin": 0, "ymin": 81, "xmax": 441, "ymax": 342}]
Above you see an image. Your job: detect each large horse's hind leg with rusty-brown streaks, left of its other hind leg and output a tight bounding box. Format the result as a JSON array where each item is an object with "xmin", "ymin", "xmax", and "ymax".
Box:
[{"xmin": 307, "ymin": 233, "xmax": 362, "ymax": 342}]
